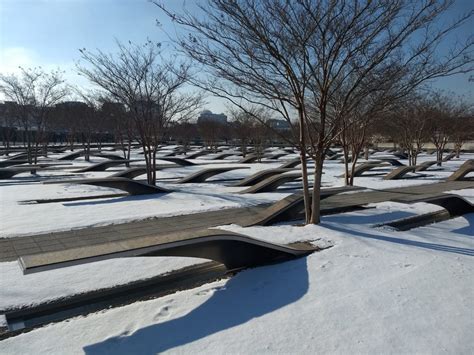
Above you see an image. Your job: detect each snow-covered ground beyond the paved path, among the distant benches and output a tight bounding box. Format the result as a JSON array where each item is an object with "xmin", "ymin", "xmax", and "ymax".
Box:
[{"xmin": 0, "ymin": 151, "xmax": 472, "ymax": 238}]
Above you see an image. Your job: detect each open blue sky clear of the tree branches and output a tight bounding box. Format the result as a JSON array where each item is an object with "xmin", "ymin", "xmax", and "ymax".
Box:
[{"xmin": 0, "ymin": 0, "xmax": 474, "ymax": 111}]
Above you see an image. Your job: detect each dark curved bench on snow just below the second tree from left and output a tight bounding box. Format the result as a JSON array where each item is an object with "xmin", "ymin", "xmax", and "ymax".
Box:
[{"xmin": 43, "ymin": 177, "xmax": 171, "ymax": 195}]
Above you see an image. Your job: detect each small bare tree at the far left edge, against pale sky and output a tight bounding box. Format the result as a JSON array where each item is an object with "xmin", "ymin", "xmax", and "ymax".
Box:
[{"xmin": 0, "ymin": 68, "xmax": 68, "ymax": 163}]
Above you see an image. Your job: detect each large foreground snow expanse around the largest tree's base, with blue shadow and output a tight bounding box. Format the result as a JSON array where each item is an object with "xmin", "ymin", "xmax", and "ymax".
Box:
[{"xmin": 0, "ymin": 206, "xmax": 474, "ymax": 354}]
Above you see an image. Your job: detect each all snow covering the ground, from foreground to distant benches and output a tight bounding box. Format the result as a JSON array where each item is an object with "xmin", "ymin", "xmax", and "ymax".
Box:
[{"xmin": 0, "ymin": 149, "xmax": 474, "ymax": 354}]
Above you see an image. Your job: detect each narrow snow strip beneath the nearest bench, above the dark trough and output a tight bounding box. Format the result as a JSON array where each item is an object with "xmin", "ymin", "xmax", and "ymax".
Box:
[{"xmin": 0, "ymin": 257, "xmax": 207, "ymax": 310}]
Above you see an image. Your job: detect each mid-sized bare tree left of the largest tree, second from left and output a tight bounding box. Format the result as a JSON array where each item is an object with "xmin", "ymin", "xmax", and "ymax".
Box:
[{"xmin": 78, "ymin": 42, "xmax": 201, "ymax": 185}]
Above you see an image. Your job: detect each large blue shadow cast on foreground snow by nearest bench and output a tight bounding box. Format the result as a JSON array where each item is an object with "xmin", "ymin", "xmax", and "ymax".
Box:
[{"xmin": 84, "ymin": 258, "xmax": 309, "ymax": 354}]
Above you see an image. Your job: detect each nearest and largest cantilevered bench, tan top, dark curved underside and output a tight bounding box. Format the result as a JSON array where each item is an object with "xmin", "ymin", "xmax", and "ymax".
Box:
[{"xmin": 19, "ymin": 229, "xmax": 318, "ymax": 274}]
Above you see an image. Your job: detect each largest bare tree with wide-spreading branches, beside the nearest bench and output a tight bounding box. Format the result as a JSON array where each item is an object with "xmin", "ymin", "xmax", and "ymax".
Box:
[{"xmin": 154, "ymin": 0, "xmax": 473, "ymax": 223}]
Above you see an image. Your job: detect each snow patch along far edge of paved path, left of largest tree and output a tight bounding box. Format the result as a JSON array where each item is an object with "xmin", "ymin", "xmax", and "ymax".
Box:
[{"xmin": 0, "ymin": 185, "xmax": 248, "ymax": 238}]
